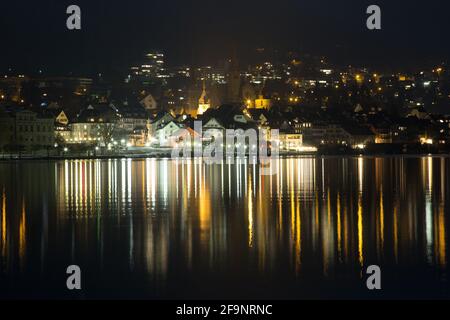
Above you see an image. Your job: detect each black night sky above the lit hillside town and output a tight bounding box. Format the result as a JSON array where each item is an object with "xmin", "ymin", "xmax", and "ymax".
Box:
[{"xmin": 0, "ymin": 0, "xmax": 450, "ymax": 75}]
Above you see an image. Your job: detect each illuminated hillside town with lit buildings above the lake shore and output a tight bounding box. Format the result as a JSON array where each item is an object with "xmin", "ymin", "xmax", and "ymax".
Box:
[{"xmin": 0, "ymin": 48, "xmax": 450, "ymax": 158}]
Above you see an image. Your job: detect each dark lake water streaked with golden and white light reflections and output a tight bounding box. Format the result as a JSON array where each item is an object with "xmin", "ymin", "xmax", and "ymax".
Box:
[{"xmin": 0, "ymin": 157, "xmax": 450, "ymax": 299}]
